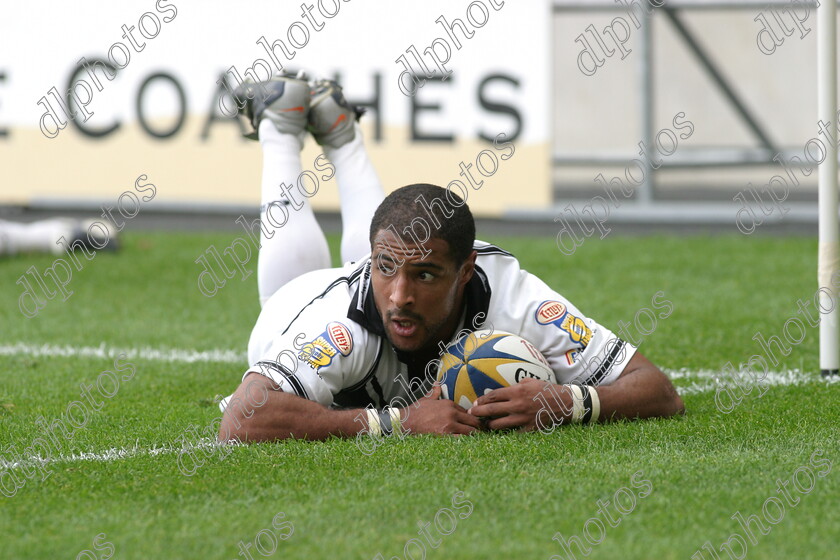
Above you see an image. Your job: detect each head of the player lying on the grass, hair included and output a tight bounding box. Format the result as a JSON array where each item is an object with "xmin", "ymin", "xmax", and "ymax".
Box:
[{"xmin": 370, "ymin": 183, "xmax": 475, "ymax": 352}]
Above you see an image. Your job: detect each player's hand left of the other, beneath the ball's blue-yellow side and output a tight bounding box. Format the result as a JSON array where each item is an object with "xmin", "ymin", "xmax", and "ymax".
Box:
[{"xmin": 402, "ymin": 385, "xmax": 481, "ymax": 435}]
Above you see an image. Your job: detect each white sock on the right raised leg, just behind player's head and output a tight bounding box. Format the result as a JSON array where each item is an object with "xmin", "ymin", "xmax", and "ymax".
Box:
[{"xmin": 324, "ymin": 124, "xmax": 385, "ymax": 262}]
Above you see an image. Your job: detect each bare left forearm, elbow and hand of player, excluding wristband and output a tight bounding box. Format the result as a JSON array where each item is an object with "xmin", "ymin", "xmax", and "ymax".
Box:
[{"xmin": 219, "ymin": 372, "xmax": 480, "ymax": 442}]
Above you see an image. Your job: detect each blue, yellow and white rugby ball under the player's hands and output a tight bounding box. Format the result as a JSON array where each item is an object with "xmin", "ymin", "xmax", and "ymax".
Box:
[{"xmin": 437, "ymin": 330, "xmax": 556, "ymax": 409}]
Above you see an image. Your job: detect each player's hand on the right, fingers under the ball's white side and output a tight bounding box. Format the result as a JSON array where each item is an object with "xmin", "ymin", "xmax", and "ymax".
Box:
[{"xmin": 469, "ymin": 378, "xmax": 572, "ymax": 432}]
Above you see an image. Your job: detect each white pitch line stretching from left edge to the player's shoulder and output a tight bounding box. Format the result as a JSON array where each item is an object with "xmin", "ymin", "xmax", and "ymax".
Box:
[{"xmin": 0, "ymin": 342, "xmax": 247, "ymax": 364}]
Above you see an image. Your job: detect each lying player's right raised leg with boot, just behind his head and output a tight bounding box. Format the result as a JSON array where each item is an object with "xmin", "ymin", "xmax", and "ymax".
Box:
[{"xmin": 309, "ymin": 80, "xmax": 385, "ymax": 262}]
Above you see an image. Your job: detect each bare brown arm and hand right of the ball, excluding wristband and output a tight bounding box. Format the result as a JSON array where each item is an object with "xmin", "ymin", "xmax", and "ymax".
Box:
[{"xmin": 470, "ymin": 351, "xmax": 685, "ymax": 431}]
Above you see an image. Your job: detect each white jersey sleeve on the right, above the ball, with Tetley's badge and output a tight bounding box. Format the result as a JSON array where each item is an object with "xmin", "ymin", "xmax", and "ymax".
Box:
[{"xmin": 487, "ymin": 253, "xmax": 636, "ymax": 385}]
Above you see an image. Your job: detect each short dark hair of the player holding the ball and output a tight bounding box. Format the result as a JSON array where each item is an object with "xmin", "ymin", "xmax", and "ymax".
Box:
[{"xmin": 370, "ymin": 183, "xmax": 475, "ymax": 266}]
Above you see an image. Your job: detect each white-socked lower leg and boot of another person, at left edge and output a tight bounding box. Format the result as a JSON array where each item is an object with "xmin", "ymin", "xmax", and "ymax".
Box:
[{"xmin": 0, "ymin": 218, "xmax": 117, "ymax": 255}]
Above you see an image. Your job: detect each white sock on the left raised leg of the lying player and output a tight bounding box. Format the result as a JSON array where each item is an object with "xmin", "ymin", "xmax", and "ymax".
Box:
[{"xmin": 257, "ymin": 119, "xmax": 330, "ymax": 304}]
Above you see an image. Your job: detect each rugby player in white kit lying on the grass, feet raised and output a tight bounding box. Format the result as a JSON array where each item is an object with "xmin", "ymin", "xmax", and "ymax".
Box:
[{"xmin": 219, "ymin": 76, "xmax": 684, "ymax": 442}]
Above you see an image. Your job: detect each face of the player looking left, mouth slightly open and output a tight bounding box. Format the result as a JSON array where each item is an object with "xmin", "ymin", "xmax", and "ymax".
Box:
[{"xmin": 371, "ymin": 230, "xmax": 475, "ymax": 352}]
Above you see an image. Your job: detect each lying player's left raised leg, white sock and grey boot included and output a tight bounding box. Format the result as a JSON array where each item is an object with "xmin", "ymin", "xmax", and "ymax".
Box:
[{"xmin": 237, "ymin": 76, "xmax": 330, "ymax": 303}]
